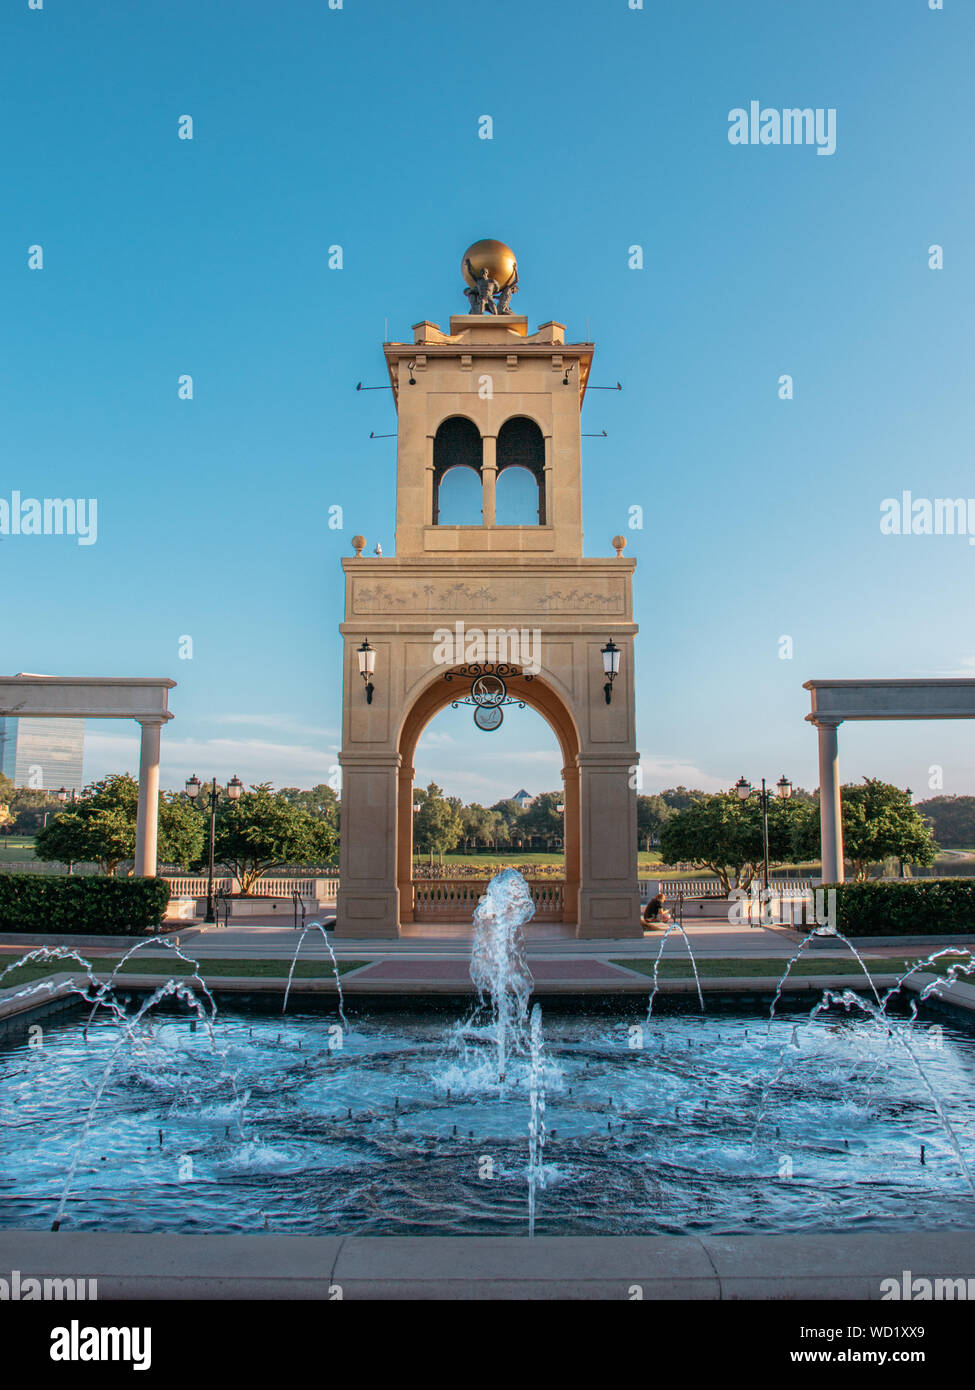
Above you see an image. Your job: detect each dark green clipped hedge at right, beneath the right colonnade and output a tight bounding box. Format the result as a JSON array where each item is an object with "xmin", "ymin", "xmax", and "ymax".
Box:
[{"xmin": 816, "ymin": 878, "xmax": 975, "ymax": 937}]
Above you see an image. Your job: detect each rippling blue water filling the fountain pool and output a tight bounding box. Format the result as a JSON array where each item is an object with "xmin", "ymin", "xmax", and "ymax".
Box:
[{"xmin": 0, "ymin": 1001, "xmax": 975, "ymax": 1236}]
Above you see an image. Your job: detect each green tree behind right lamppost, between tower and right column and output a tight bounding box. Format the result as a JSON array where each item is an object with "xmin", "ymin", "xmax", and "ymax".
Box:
[{"xmin": 661, "ymin": 791, "xmax": 809, "ymax": 895}]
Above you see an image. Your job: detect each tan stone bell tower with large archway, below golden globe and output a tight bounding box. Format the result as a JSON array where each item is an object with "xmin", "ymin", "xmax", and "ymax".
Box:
[{"xmin": 337, "ymin": 251, "xmax": 641, "ymax": 937}]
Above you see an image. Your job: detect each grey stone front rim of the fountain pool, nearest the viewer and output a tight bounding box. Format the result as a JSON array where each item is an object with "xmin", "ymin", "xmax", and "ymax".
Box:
[{"xmin": 0, "ymin": 1229, "xmax": 975, "ymax": 1301}]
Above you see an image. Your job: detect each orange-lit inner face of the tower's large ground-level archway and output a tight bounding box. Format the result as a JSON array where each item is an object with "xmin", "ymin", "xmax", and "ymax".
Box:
[{"xmin": 396, "ymin": 669, "xmax": 581, "ymax": 923}]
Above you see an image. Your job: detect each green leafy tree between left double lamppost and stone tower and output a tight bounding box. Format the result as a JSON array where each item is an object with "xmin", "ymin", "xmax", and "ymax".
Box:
[{"xmin": 208, "ymin": 783, "xmax": 338, "ymax": 895}]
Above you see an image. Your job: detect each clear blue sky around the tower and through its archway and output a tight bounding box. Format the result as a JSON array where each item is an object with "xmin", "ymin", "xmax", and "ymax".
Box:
[{"xmin": 0, "ymin": 0, "xmax": 975, "ymax": 801}]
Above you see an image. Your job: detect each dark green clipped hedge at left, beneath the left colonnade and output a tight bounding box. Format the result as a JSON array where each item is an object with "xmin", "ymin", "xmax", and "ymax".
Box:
[{"xmin": 0, "ymin": 873, "xmax": 170, "ymax": 937}]
